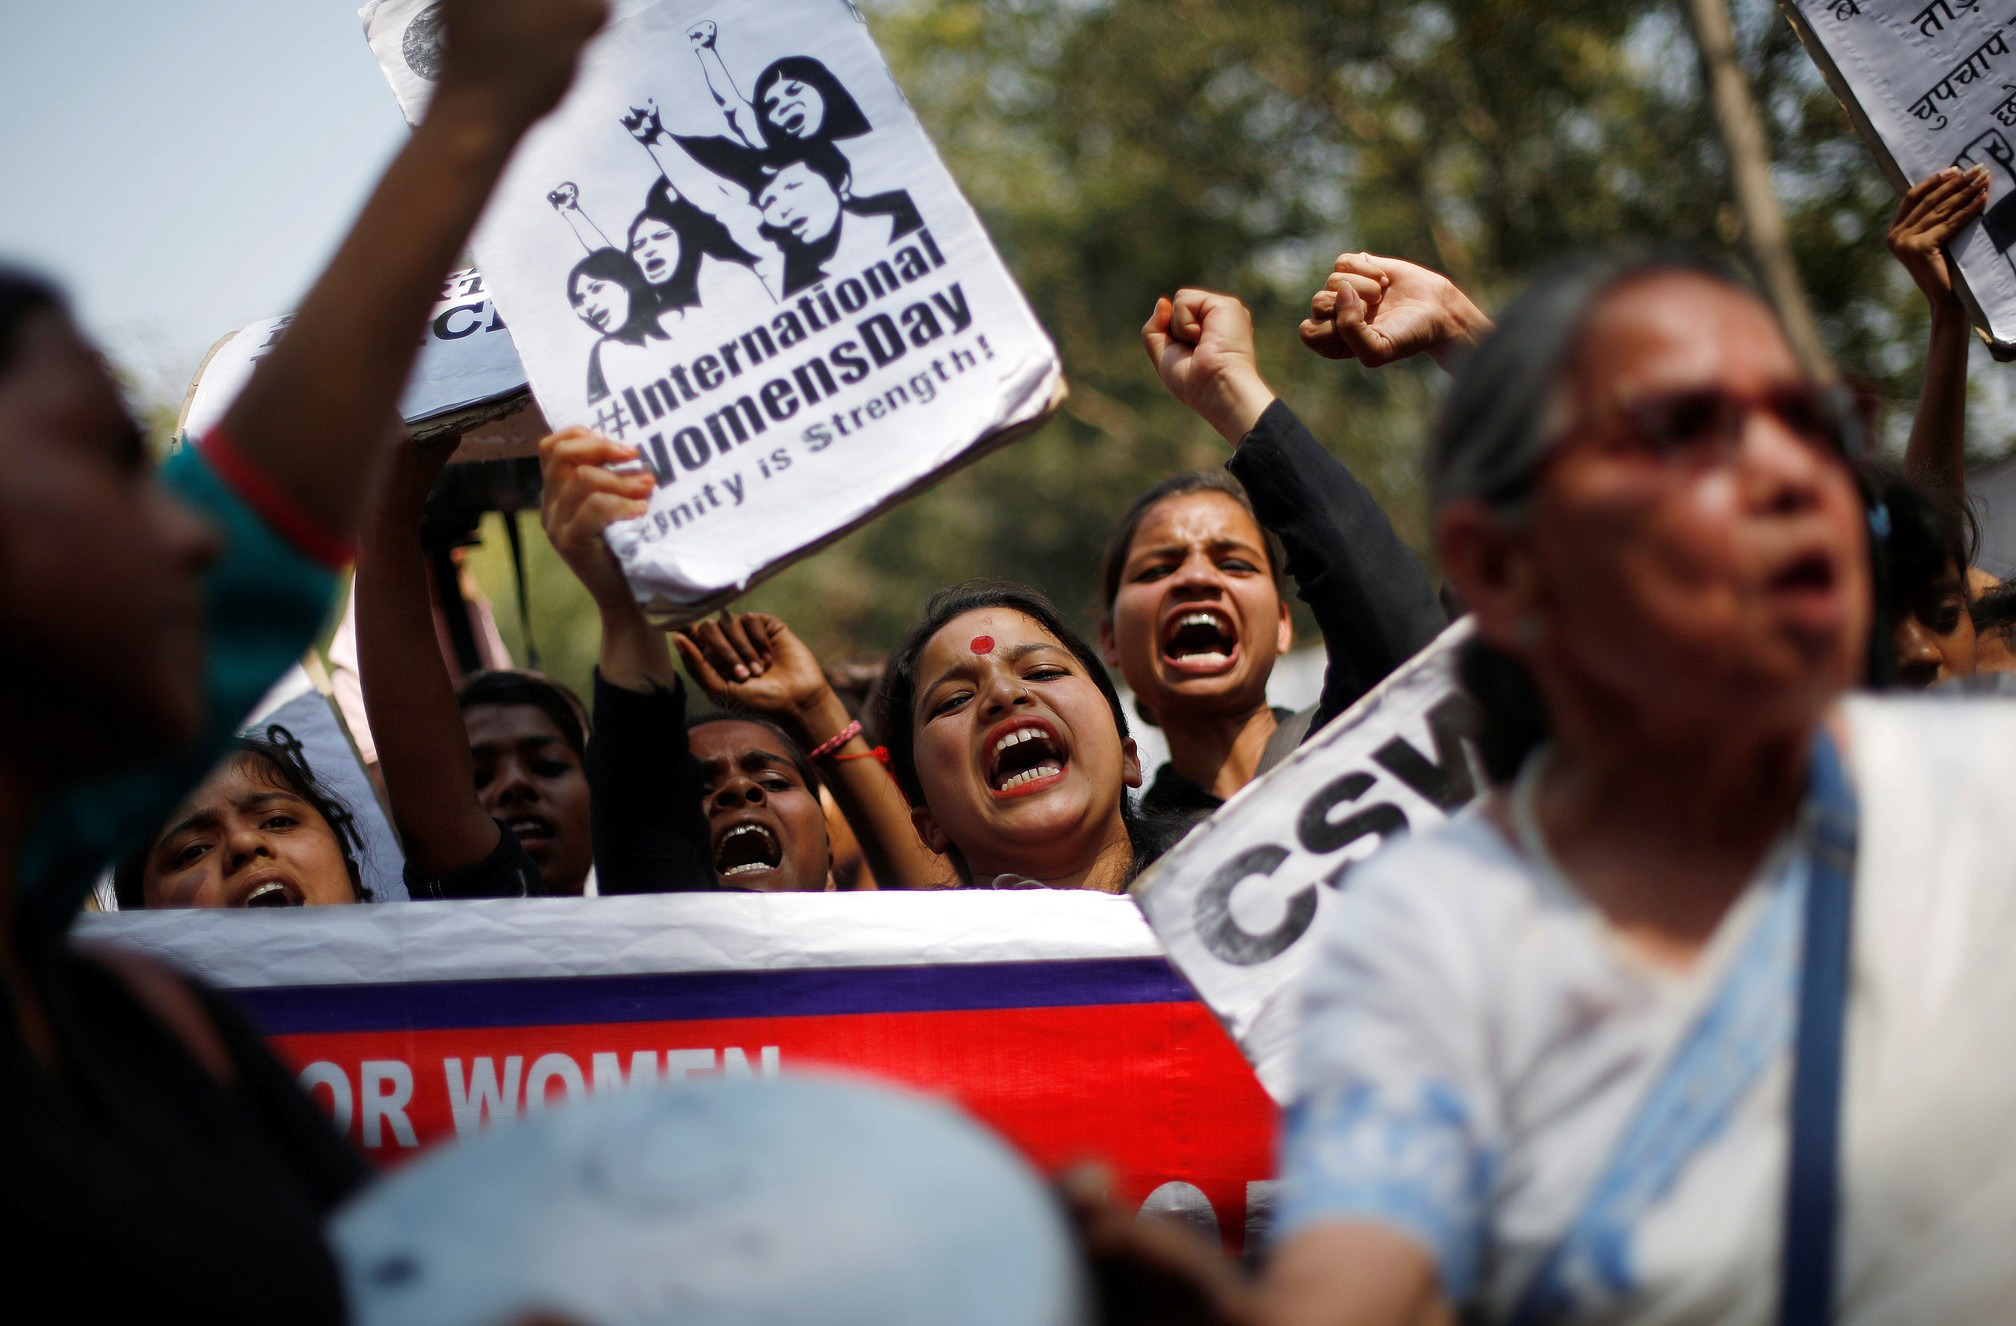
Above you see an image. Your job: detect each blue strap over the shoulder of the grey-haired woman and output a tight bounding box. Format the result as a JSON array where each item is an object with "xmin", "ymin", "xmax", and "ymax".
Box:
[{"xmin": 1778, "ymin": 734, "xmax": 1857, "ymax": 1326}]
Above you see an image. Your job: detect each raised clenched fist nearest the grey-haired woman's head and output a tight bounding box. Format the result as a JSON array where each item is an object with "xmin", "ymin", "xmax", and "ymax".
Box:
[{"xmin": 1300, "ymin": 254, "xmax": 1492, "ymax": 369}]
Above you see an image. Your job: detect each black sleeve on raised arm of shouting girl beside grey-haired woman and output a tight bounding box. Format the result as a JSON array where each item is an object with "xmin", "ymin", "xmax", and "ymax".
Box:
[{"xmin": 1226, "ymin": 401, "xmax": 1447, "ymax": 732}]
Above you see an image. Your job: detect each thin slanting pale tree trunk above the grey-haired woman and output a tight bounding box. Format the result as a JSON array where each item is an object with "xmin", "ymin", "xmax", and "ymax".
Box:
[{"xmin": 1687, "ymin": 0, "xmax": 1835, "ymax": 381}]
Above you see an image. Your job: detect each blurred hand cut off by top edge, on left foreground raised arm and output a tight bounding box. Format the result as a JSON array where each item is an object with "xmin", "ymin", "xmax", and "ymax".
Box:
[{"xmin": 427, "ymin": 0, "xmax": 609, "ymax": 129}]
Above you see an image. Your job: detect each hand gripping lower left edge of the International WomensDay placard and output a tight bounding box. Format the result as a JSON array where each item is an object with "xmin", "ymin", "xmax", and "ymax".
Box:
[{"xmin": 538, "ymin": 427, "xmax": 657, "ymax": 617}]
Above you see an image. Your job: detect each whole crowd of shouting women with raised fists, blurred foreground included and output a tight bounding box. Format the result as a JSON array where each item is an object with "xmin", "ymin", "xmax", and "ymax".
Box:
[{"xmin": 0, "ymin": 0, "xmax": 2016, "ymax": 1326}]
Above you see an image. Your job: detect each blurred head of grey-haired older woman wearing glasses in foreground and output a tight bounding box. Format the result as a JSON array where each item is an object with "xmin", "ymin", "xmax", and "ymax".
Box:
[{"xmin": 1429, "ymin": 256, "xmax": 1871, "ymax": 778}]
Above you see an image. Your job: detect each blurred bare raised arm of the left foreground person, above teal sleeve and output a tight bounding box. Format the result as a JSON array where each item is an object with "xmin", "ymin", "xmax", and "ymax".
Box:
[{"xmin": 224, "ymin": 0, "xmax": 607, "ymax": 540}]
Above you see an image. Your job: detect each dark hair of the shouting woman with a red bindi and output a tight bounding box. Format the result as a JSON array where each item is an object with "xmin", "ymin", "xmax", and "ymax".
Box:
[{"xmin": 877, "ymin": 580, "xmax": 1173, "ymax": 883}]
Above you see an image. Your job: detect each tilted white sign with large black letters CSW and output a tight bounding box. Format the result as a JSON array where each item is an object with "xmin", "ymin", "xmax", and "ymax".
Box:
[{"xmin": 1135, "ymin": 619, "xmax": 1482, "ymax": 1104}]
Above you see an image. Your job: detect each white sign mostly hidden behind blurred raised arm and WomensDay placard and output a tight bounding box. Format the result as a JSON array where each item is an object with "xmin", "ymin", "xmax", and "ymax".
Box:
[{"xmin": 175, "ymin": 268, "xmax": 538, "ymax": 447}]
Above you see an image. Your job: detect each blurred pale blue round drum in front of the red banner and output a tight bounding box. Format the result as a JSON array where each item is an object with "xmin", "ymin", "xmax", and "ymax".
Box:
[{"xmin": 331, "ymin": 1076, "xmax": 1087, "ymax": 1326}]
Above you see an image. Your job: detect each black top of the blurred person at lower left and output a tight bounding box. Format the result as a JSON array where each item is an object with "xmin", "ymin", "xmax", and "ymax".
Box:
[{"xmin": 0, "ymin": 937, "xmax": 369, "ymax": 1322}]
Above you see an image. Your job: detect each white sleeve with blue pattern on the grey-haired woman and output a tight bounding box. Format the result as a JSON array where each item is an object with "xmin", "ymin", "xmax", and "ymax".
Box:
[{"xmin": 1274, "ymin": 824, "xmax": 1498, "ymax": 1302}]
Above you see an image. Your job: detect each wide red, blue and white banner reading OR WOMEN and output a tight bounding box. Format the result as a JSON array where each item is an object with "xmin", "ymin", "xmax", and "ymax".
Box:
[{"xmin": 79, "ymin": 891, "xmax": 1274, "ymax": 1247}]
